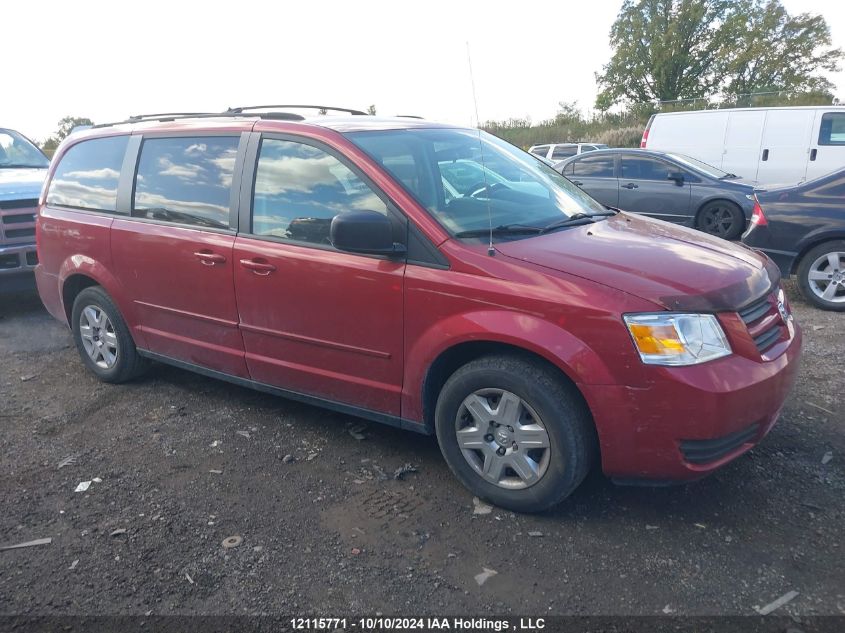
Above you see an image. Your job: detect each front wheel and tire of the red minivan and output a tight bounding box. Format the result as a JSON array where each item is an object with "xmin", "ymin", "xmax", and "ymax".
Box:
[{"xmin": 435, "ymin": 355, "xmax": 596, "ymax": 512}]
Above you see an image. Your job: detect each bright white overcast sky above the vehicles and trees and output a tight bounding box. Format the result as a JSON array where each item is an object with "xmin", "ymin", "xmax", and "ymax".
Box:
[{"xmin": 0, "ymin": 0, "xmax": 845, "ymax": 140}]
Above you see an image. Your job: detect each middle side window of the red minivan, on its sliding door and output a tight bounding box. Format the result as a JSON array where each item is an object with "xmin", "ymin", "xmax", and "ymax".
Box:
[{"xmin": 132, "ymin": 136, "xmax": 238, "ymax": 229}]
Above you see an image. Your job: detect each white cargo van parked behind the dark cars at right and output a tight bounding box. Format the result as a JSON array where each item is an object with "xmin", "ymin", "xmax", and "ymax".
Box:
[{"xmin": 640, "ymin": 106, "xmax": 845, "ymax": 186}]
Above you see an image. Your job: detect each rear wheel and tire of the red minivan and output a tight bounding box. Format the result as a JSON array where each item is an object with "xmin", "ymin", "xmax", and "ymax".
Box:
[{"xmin": 71, "ymin": 286, "xmax": 147, "ymax": 383}]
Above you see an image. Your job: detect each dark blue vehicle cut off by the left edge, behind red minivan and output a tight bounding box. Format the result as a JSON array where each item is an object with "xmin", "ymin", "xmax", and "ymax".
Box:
[{"xmin": 0, "ymin": 128, "xmax": 50, "ymax": 293}]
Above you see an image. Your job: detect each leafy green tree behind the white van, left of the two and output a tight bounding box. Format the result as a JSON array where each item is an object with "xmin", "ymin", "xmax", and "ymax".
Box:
[{"xmin": 596, "ymin": 0, "xmax": 734, "ymax": 110}]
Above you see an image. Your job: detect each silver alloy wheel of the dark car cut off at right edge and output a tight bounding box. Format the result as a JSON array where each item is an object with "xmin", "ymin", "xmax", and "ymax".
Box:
[{"xmin": 798, "ymin": 241, "xmax": 845, "ymax": 311}]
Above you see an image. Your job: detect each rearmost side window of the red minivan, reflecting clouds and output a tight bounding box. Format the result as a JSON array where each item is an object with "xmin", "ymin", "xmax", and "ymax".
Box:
[{"xmin": 47, "ymin": 136, "xmax": 129, "ymax": 212}]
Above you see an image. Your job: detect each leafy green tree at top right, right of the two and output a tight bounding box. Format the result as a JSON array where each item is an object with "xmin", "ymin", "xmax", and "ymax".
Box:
[{"xmin": 724, "ymin": 0, "xmax": 842, "ymax": 96}]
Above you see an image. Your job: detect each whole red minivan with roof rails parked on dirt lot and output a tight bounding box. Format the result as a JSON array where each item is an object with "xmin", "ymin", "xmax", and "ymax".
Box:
[{"xmin": 36, "ymin": 106, "xmax": 801, "ymax": 511}]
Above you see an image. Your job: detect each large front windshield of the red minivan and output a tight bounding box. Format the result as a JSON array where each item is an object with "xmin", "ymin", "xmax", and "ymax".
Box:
[{"xmin": 347, "ymin": 128, "xmax": 609, "ymax": 241}]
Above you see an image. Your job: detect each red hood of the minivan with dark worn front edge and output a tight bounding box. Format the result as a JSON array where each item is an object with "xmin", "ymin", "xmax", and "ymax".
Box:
[{"xmin": 496, "ymin": 213, "xmax": 780, "ymax": 312}]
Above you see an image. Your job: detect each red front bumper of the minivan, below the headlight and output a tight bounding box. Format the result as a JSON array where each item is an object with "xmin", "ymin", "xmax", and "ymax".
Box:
[{"xmin": 585, "ymin": 325, "xmax": 801, "ymax": 483}]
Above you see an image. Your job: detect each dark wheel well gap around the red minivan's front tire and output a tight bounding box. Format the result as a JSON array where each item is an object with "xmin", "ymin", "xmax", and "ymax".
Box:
[{"xmin": 422, "ymin": 341, "xmax": 589, "ymax": 431}]
